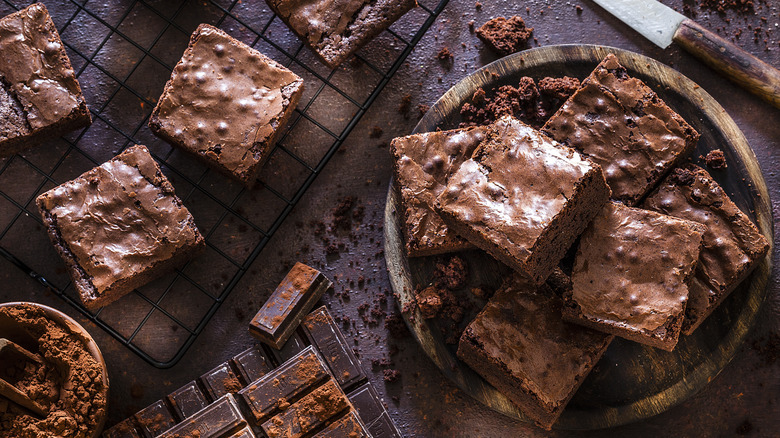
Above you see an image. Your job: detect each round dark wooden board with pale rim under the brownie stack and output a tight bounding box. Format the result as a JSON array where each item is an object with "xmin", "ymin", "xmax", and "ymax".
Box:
[{"xmin": 385, "ymin": 45, "xmax": 774, "ymax": 429}]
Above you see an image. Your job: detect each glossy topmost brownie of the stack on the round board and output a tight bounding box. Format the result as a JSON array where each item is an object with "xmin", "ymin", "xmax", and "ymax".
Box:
[{"xmin": 435, "ymin": 116, "xmax": 610, "ymax": 284}]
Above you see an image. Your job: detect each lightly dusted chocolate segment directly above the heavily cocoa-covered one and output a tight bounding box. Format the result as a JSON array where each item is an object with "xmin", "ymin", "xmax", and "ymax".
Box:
[{"xmin": 238, "ymin": 346, "xmax": 330, "ymax": 424}]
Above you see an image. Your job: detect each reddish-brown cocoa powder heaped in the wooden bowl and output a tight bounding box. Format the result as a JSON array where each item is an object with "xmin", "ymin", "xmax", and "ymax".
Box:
[{"xmin": 0, "ymin": 303, "xmax": 108, "ymax": 438}]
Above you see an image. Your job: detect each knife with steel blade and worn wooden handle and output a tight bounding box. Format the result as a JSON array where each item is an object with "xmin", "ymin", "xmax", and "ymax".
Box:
[{"xmin": 593, "ymin": 0, "xmax": 780, "ymax": 108}]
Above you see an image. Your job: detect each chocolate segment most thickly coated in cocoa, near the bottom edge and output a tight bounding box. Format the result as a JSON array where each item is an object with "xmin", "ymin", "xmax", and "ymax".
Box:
[{"xmin": 262, "ymin": 380, "xmax": 350, "ymax": 438}]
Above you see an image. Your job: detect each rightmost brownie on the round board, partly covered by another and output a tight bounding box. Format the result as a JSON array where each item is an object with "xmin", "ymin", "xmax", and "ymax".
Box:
[{"xmin": 643, "ymin": 164, "xmax": 769, "ymax": 334}]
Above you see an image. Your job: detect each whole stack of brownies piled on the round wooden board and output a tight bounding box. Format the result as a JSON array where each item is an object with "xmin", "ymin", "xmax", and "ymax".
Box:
[{"xmin": 392, "ymin": 55, "xmax": 769, "ymax": 429}]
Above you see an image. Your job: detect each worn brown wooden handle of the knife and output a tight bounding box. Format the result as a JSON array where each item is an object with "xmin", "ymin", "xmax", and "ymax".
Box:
[{"xmin": 673, "ymin": 20, "xmax": 780, "ymax": 108}]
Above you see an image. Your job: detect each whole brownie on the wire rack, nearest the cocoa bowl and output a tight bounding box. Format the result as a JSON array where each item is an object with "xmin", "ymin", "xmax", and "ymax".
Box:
[{"xmin": 36, "ymin": 146, "xmax": 204, "ymax": 310}]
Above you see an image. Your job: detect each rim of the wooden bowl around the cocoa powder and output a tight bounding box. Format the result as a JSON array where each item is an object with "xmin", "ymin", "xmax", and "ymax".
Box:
[{"xmin": 0, "ymin": 302, "xmax": 108, "ymax": 438}]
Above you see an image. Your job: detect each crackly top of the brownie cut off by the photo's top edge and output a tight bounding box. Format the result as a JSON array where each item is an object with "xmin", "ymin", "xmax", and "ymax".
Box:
[{"xmin": 269, "ymin": 0, "xmax": 371, "ymax": 47}]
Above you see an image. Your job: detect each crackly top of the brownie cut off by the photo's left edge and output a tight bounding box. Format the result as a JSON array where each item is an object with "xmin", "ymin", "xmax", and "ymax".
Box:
[{"xmin": 0, "ymin": 3, "xmax": 81, "ymax": 129}]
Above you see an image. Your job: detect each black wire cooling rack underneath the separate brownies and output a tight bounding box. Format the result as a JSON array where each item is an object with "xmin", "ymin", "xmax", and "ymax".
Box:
[{"xmin": 0, "ymin": 0, "xmax": 448, "ymax": 368}]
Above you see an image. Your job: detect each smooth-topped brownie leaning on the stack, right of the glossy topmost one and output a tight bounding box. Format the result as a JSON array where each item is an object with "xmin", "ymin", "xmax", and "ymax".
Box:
[{"xmin": 563, "ymin": 202, "xmax": 706, "ymax": 351}]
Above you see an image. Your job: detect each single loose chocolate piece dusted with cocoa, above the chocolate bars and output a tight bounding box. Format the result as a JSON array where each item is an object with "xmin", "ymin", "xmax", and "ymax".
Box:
[{"xmin": 249, "ymin": 263, "xmax": 333, "ymax": 349}]
